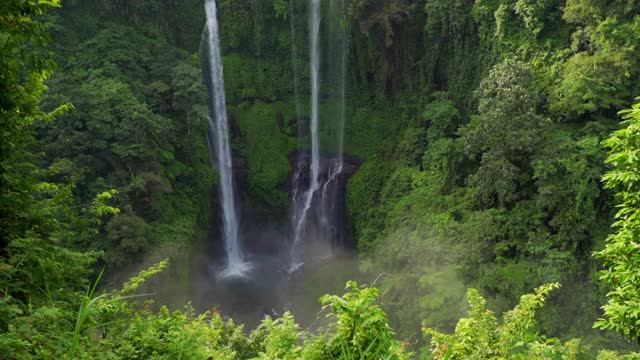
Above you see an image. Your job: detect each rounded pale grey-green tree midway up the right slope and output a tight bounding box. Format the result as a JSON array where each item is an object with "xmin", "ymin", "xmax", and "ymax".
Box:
[{"xmin": 460, "ymin": 59, "xmax": 547, "ymax": 207}]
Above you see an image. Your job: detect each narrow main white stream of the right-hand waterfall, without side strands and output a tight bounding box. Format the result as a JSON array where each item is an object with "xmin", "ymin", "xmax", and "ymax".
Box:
[{"xmin": 289, "ymin": 0, "xmax": 320, "ymax": 272}]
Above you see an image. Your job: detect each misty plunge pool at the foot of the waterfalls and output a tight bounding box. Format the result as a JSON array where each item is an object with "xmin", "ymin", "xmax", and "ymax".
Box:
[{"xmin": 191, "ymin": 230, "xmax": 363, "ymax": 330}]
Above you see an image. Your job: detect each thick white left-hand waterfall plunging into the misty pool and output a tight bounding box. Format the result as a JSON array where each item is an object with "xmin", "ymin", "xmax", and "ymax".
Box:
[{"xmin": 205, "ymin": 0, "xmax": 249, "ymax": 276}]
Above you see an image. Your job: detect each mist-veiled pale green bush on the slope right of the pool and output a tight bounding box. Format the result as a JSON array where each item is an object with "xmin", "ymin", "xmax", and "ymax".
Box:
[{"xmin": 362, "ymin": 180, "xmax": 468, "ymax": 342}]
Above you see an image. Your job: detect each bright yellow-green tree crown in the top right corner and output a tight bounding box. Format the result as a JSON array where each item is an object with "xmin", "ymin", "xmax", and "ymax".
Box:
[{"xmin": 550, "ymin": 9, "xmax": 640, "ymax": 117}]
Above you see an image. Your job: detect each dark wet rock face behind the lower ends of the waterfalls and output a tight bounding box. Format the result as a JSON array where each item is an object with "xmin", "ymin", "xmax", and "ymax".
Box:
[{"xmin": 211, "ymin": 151, "xmax": 361, "ymax": 257}]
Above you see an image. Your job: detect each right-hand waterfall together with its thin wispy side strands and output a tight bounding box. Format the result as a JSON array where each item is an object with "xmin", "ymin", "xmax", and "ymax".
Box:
[{"xmin": 289, "ymin": 0, "xmax": 346, "ymax": 273}]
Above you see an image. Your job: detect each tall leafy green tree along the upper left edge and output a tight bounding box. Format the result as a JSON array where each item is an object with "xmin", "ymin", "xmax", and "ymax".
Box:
[{"xmin": 0, "ymin": 1, "xmax": 63, "ymax": 247}]
